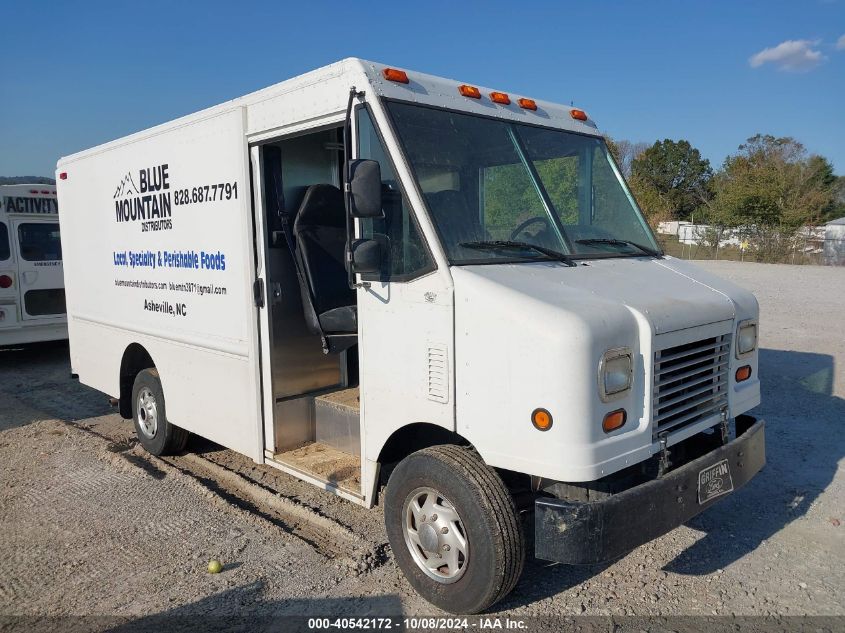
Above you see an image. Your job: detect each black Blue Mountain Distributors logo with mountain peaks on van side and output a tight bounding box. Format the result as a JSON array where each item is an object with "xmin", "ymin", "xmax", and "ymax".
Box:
[{"xmin": 113, "ymin": 163, "xmax": 173, "ymax": 232}]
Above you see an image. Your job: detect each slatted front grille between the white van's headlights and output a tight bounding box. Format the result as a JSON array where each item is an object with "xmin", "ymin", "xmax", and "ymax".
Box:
[{"xmin": 652, "ymin": 334, "xmax": 731, "ymax": 438}]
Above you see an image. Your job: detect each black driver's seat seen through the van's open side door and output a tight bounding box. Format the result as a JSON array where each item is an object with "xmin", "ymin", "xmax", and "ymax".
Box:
[{"xmin": 293, "ymin": 185, "xmax": 358, "ymax": 334}]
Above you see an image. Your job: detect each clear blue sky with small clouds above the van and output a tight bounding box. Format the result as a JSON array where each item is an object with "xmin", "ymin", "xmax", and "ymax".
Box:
[{"xmin": 0, "ymin": 0, "xmax": 845, "ymax": 176}]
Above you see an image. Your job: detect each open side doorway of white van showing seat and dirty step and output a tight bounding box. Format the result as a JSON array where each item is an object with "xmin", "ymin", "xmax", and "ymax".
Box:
[{"xmin": 260, "ymin": 126, "xmax": 361, "ymax": 495}]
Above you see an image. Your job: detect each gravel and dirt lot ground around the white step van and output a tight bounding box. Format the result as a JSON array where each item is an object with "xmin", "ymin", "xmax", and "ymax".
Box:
[{"xmin": 0, "ymin": 262, "xmax": 845, "ymax": 630}]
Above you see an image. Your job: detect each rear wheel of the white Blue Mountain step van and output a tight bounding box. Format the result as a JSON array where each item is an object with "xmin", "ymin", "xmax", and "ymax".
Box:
[{"xmin": 132, "ymin": 369, "xmax": 190, "ymax": 455}]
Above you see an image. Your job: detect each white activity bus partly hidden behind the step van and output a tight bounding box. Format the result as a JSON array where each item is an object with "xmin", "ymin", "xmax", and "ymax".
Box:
[{"xmin": 0, "ymin": 184, "xmax": 67, "ymax": 347}]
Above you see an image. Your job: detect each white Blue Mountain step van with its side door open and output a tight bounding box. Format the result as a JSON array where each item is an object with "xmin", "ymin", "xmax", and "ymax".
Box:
[{"xmin": 57, "ymin": 59, "xmax": 765, "ymax": 613}]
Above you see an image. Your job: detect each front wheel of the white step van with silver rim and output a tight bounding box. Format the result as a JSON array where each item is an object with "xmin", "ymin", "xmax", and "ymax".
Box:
[{"xmin": 384, "ymin": 445, "xmax": 525, "ymax": 614}]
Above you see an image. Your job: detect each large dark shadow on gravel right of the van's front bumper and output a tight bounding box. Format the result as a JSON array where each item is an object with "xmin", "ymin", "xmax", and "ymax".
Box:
[{"xmin": 664, "ymin": 349, "xmax": 845, "ymax": 575}]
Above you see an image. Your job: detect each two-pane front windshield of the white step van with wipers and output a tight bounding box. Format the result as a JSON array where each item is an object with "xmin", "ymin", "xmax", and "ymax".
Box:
[{"xmin": 387, "ymin": 102, "xmax": 660, "ymax": 264}]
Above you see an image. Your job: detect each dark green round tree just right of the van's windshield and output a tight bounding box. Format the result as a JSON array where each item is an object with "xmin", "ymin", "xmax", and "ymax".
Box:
[{"xmin": 631, "ymin": 139, "xmax": 713, "ymax": 220}]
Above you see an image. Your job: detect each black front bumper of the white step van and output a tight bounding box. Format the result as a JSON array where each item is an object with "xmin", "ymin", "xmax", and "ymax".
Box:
[{"xmin": 534, "ymin": 416, "xmax": 766, "ymax": 565}]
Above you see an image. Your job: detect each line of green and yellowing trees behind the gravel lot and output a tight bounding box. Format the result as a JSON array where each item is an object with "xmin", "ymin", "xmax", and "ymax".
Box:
[{"xmin": 607, "ymin": 134, "xmax": 845, "ymax": 259}]
